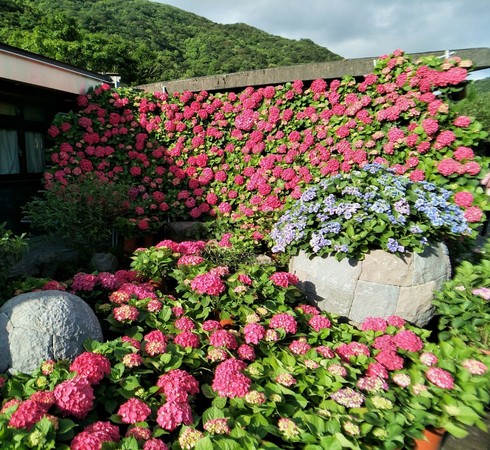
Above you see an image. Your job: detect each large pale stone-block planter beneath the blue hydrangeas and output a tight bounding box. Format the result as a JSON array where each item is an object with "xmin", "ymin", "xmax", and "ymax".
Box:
[{"xmin": 289, "ymin": 243, "xmax": 451, "ymax": 326}]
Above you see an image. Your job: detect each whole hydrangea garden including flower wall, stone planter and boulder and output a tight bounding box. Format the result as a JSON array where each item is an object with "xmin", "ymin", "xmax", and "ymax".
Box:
[{"xmin": 0, "ymin": 51, "xmax": 490, "ymax": 450}]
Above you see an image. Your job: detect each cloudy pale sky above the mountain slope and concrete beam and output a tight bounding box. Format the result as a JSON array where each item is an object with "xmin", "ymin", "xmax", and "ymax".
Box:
[{"xmin": 153, "ymin": 0, "xmax": 490, "ymax": 75}]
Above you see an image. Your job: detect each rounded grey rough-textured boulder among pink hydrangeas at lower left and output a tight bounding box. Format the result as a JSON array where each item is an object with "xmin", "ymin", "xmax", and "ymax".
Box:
[{"xmin": 0, "ymin": 291, "xmax": 103, "ymax": 373}]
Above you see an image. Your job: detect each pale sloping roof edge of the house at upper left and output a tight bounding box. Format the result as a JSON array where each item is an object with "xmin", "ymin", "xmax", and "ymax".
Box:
[{"xmin": 0, "ymin": 43, "xmax": 112, "ymax": 94}]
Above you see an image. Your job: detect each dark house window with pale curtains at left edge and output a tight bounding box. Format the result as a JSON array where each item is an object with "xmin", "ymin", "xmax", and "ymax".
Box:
[{"xmin": 0, "ymin": 102, "xmax": 46, "ymax": 175}]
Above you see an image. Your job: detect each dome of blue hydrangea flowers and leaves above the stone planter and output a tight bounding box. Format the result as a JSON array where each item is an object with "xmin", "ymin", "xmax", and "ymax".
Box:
[{"xmin": 271, "ymin": 164, "xmax": 471, "ymax": 257}]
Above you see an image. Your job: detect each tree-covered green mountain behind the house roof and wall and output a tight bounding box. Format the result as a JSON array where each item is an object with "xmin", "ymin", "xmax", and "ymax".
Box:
[{"xmin": 0, "ymin": 0, "xmax": 342, "ymax": 85}]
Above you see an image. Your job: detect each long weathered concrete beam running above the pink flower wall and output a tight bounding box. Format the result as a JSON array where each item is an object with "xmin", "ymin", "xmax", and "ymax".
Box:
[{"xmin": 138, "ymin": 47, "xmax": 490, "ymax": 93}]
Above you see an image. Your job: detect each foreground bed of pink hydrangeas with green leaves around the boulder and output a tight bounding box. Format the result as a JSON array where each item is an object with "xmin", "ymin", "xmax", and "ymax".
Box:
[{"xmin": 0, "ymin": 237, "xmax": 490, "ymax": 450}]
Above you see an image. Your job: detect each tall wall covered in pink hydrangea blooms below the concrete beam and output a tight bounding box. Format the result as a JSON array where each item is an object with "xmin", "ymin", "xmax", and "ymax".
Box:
[{"xmin": 46, "ymin": 51, "xmax": 488, "ymax": 236}]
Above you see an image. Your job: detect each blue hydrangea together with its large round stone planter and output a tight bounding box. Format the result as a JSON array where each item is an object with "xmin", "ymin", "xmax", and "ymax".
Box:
[{"xmin": 270, "ymin": 164, "xmax": 474, "ymax": 325}]
